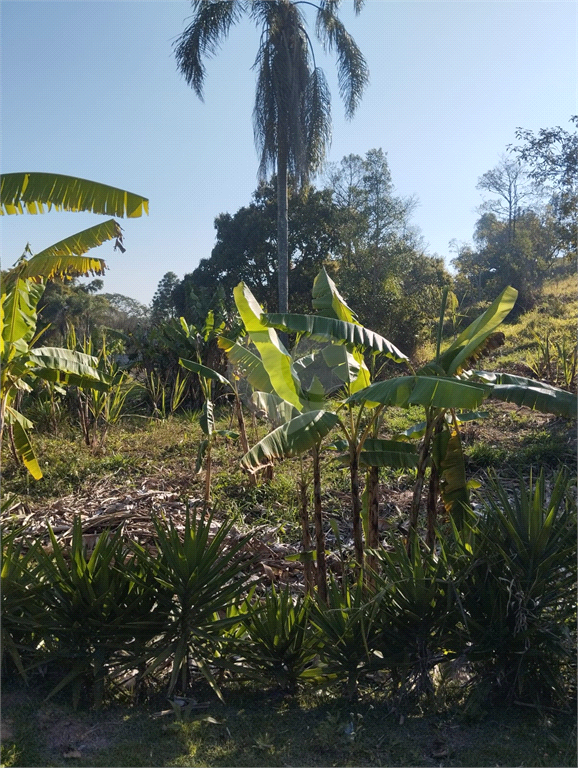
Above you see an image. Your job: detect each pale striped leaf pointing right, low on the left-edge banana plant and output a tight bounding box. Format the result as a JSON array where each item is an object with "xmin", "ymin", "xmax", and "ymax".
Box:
[{"xmin": 28, "ymin": 347, "xmax": 112, "ymax": 391}]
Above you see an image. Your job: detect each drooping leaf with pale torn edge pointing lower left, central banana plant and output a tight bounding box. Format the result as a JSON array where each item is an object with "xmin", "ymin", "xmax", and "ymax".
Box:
[{"xmin": 241, "ymin": 410, "xmax": 339, "ymax": 472}]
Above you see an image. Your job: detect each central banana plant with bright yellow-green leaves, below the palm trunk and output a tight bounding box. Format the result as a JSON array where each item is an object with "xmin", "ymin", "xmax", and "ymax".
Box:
[{"xmin": 235, "ymin": 269, "xmax": 412, "ymax": 567}]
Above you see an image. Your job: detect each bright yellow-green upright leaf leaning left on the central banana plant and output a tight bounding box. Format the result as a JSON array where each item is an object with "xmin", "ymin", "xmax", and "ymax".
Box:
[{"xmin": 233, "ymin": 283, "xmax": 303, "ymax": 411}]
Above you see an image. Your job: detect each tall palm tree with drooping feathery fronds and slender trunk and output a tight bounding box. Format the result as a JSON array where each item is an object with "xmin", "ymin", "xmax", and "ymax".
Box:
[{"xmin": 176, "ymin": 0, "xmax": 369, "ymax": 312}]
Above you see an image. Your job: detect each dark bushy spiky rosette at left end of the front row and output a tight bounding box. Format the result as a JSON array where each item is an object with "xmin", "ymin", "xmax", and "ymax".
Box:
[{"xmin": 35, "ymin": 517, "xmax": 164, "ymax": 706}]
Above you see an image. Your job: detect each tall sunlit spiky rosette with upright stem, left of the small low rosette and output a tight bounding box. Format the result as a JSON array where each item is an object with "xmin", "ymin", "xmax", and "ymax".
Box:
[{"xmin": 149, "ymin": 507, "xmax": 250, "ymax": 699}]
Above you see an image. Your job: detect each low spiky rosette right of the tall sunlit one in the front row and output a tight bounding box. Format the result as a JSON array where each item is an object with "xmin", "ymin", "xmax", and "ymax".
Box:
[{"xmin": 219, "ymin": 586, "xmax": 318, "ymax": 693}]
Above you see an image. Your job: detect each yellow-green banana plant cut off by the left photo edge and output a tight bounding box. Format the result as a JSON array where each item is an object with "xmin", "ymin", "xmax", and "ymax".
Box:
[{"xmin": 0, "ymin": 173, "xmax": 148, "ymax": 479}]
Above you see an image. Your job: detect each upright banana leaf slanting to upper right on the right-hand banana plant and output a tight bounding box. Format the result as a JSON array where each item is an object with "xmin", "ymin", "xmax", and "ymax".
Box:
[{"xmin": 437, "ymin": 286, "xmax": 518, "ymax": 375}]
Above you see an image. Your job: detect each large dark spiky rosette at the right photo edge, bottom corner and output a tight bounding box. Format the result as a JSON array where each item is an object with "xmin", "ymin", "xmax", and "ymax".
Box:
[{"xmin": 454, "ymin": 464, "xmax": 576, "ymax": 704}]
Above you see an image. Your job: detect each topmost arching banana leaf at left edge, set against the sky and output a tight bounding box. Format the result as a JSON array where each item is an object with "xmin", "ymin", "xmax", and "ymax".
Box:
[{"xmin": 0, "ymin": 173, "xmax": 149, "ymax": 218}]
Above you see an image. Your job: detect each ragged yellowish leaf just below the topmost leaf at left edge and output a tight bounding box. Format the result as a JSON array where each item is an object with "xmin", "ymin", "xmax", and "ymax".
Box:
[{"xmin": 18, "ymin": 219, "xmax": 122, "ymax": 280}]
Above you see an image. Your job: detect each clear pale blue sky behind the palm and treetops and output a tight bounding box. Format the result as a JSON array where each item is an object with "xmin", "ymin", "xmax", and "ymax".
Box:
[{"xmin": 0, "ymin": 0, "xmax": 578, "ymax": 303}]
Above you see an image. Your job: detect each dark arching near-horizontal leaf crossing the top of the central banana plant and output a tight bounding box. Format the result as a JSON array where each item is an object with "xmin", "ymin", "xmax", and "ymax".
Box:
[{"xmin": 262, "ymin": 314, "xmax": 408, "ymax": 363}]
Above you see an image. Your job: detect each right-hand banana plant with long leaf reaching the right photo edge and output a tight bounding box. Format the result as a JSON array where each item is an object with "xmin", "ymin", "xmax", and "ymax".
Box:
[{"xmin": 348, "ymin": 287, "xmax": 576, "ymax": 548}]
